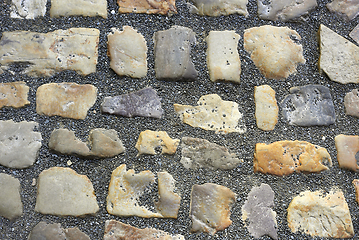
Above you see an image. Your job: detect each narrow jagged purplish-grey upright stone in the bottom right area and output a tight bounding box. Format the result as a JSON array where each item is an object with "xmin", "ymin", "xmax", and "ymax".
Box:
[{"xmin": 242, "ymin": 183, "xmax": 278, "ymax": 239}]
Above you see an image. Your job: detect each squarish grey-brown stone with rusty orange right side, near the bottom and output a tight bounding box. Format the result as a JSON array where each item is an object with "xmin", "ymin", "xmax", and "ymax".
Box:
[{"xmin": 190, "ymin": 183, "xmax": 236, "ymax": 235}]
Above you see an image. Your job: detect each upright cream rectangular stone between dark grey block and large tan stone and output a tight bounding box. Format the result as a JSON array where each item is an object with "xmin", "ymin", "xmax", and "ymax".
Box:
[{"xmin": 206, "ymin": 31, "xmax": 241, "ymax": 83}]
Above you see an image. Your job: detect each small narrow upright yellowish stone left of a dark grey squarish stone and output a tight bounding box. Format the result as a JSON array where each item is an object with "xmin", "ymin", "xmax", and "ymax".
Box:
[{"xmin": 254, "ymin": 85, "xmax": 279, "ymax": 131}]
